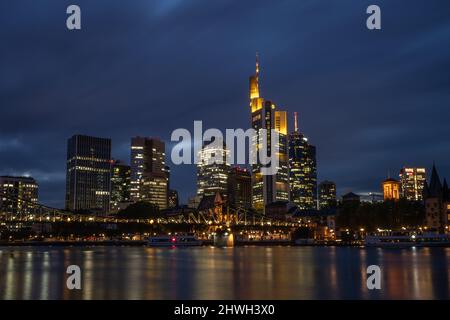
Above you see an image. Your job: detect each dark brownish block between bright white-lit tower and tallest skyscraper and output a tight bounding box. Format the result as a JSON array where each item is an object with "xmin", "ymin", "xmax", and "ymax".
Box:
[{"xmin": 228, "ymin": 167, "xmax": 252, "ymax": 209}]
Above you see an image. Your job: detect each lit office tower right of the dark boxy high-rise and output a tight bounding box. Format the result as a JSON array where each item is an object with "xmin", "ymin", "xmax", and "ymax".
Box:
[{"xmin": 130, "ymin": 137, "xmax": 168, "ymax": 209}]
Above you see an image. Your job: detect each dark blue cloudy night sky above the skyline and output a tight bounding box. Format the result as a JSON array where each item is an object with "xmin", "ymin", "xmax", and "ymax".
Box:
[{"xmin": 0, "ymin": 0, "xmax": 450, "ymax": 207}]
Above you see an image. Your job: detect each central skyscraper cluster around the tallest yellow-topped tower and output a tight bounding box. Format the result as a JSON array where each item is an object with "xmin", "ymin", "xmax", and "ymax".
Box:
[{"xmin": 193, "ymin": 57, "xmax": 324, "ymax": 213}]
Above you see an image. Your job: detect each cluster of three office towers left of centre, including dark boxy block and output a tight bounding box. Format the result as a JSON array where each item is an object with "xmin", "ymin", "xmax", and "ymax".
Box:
[{"xmin": 62, "ymin": 135, "xmax": 171, "ymax": 215}]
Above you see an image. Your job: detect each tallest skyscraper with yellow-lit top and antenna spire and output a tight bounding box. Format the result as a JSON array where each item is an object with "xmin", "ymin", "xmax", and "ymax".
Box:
[{"xmin": 249, "ymin": 56, "xmax": 289, "ymax": 212}]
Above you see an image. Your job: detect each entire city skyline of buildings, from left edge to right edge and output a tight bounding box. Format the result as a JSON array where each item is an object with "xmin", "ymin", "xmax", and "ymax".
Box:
[{"xmin": 0, "ymin": 57, "xmax": 450, "ymax": 228}]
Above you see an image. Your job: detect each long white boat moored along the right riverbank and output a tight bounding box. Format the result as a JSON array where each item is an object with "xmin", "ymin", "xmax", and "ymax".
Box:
[{"xmin": 365, "ymin": 231, "xmax": 450, "ymax": 248}]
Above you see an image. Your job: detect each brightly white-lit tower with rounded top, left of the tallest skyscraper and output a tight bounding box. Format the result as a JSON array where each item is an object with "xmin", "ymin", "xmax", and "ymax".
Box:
[{"xmin": 197, "ymin": 141, "xmax": 230, "ymax": 196}]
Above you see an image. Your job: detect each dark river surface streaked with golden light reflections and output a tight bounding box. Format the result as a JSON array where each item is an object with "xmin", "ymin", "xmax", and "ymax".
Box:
[{"xmin": 0, "ymin": 247, "xmax": 450, "ymax": 300}]
